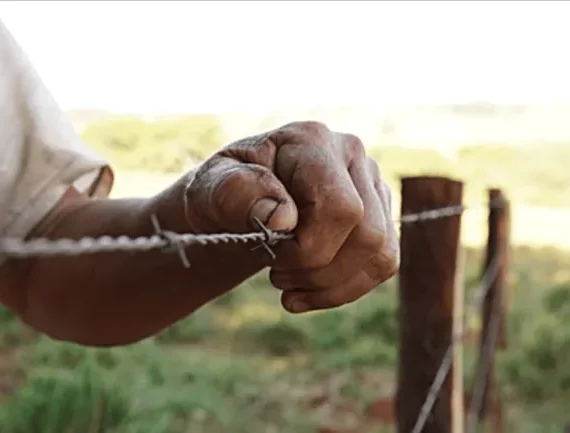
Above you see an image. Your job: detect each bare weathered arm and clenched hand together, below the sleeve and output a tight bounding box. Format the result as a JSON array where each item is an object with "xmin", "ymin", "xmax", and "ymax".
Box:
[{"xmin": 0, "ymin": 122, "xmax": 399, "ymax": 346}]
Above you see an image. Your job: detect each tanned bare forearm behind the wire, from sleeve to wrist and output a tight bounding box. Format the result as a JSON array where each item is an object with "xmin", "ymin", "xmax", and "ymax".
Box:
[{"xmin": 0, "ymin": 174, "xmax": 263, "ymax": 346}]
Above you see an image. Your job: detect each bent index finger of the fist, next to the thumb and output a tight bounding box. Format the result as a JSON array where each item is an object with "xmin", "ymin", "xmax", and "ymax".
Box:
[{"xmin": 272, "ymin": 124, "xmax": 364, "ymax": 270}]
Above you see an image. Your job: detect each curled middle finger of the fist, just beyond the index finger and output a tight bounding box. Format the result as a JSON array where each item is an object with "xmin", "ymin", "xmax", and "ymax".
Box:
[{"xmin": 270, "ymin": 147, "xmax": 384, "ymax": 290}]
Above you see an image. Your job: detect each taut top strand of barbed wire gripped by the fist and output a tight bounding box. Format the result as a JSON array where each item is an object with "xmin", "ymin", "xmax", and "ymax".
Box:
[{"xmin": 0, "ymin": 199, "xmax": 500, "ymax": 260}]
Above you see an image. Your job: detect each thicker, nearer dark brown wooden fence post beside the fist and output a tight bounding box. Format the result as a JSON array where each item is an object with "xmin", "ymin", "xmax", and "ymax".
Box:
[{"xmin": 395, "ymin": 176, "xmax": 463, "ymax": 433}]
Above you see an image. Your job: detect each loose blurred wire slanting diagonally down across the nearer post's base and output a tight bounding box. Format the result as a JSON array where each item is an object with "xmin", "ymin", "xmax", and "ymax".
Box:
[{"xmin": 411, "ymin": 253, "xmax": 499, "ymax": 433}]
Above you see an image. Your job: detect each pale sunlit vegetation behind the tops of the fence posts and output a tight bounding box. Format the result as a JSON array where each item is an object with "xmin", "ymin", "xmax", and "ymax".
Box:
[{"xmin": 370, "ymin": 144, "xmax": 570, "ymax": 207}]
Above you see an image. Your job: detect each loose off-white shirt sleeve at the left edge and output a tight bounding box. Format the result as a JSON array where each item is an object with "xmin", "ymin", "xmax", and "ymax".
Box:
[{"xmin": 0, "ymin": 21, "xmax": 113, "ymax": 248}]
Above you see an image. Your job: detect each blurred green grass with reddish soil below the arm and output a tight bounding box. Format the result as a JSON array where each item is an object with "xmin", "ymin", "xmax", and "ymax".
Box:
[{"xmin": 0, "ymin": 247, "xmax": 570, "ymax": 433}]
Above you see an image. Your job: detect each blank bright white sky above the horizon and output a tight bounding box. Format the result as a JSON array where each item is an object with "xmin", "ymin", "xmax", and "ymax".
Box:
[{"xmin": 0, "ymin": 1, "xmax": 570, "ymax": 112}]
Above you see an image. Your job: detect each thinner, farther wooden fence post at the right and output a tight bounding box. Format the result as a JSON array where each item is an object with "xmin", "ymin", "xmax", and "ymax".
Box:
[{"xmin": 474, "ymin": 189, "xmax": 510, "ymax": 433}]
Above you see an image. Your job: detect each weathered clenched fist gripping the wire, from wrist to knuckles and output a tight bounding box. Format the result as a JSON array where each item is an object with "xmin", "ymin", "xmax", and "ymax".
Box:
[{"xmin": 186, "ymin": 122, "xmax": 400, "ymax": 313}]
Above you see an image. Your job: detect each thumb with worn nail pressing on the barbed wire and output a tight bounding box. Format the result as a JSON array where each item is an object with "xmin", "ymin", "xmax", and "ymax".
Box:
[{"xmin": 186, "ymin": 157, "xmax": 298, "ymax": 233}]
